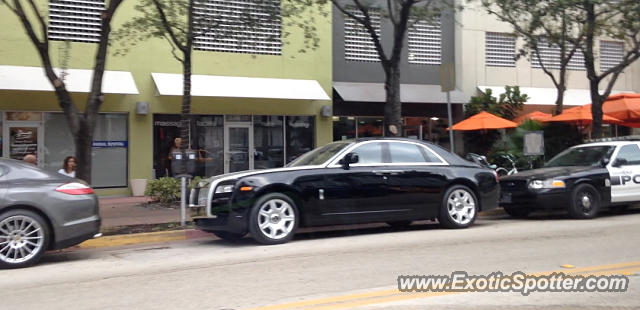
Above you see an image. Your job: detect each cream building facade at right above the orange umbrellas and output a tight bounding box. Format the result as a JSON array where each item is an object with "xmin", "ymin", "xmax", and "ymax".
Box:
[{"xmin": 455, "ymin": 2, "xmax": 640, "ymax": 113}]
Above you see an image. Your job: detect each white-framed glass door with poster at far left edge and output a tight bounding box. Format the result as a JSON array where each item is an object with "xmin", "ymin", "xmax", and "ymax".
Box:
[{"xmin": 2, "ymin": 121, "xmax": 44, "ymax": 166}]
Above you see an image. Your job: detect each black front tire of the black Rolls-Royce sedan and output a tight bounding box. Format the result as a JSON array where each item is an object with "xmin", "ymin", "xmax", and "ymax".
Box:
[{"xmin": 249, "ymin": 193, "xmax": 300, "ymax": 245}]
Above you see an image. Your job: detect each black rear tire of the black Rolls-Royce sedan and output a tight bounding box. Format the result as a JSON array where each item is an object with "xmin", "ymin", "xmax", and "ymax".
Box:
[{"xmin": 438, "ymin": 185, "xmax": 478, "ymax": 229}]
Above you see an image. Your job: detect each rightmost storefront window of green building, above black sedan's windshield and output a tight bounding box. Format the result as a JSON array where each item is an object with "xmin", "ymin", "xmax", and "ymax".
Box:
[{"xmin": 286, "ymin": 116, "xmax": 315, "ymax": 163}]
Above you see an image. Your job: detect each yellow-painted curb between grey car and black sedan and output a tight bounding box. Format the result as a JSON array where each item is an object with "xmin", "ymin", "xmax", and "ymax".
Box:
[{"xmin": 76, "ymin": 229, "xmax": 210, "ymax": 249}]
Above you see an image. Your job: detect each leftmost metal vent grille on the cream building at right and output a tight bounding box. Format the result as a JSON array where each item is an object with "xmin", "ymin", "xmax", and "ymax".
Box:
[{"xmin": 485, "ymin": 32, "xmax": 516, "ymax": 67}]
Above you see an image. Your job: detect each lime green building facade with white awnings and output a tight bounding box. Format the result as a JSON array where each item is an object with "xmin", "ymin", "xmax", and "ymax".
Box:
[{"xmin": 0, "ymin": 0, "xmax": 332, "ymax": 195}]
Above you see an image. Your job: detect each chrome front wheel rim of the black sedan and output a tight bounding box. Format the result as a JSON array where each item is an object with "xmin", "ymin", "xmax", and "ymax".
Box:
[{"xmin": 258, "ymin": 199, "xmax": 296, "ymax": 240}]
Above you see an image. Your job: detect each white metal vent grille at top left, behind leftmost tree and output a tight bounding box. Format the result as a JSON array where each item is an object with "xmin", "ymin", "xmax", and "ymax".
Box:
[{"xmin": 48, "ymin": 0, "xmax": 105, "ymax": 42}]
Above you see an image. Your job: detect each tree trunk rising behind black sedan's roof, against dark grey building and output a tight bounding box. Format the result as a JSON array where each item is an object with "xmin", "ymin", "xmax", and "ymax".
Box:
[{"xmin": 384, "ymin": 63, "xmax": 403, "ymax": 137}]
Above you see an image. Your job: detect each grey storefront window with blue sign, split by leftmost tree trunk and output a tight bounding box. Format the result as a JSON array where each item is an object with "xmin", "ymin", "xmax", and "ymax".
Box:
[{"xmin": 43, "ymin": 113, "xmax": 129, "ymax": 188}]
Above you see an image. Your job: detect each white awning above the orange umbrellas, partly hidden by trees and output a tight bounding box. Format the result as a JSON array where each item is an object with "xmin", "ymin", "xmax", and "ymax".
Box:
[{"xmin": 478, "ymin": 86, "xmax": 633, "ymax": 106}]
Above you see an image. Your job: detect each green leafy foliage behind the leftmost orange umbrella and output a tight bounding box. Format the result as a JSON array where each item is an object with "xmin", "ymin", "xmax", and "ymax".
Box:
[{"xmin": 465, "ymin": 86, "xmax": 529, "ymax": 120}]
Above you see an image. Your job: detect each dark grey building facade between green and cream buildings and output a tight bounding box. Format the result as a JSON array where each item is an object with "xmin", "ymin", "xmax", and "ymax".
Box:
[{"xmin": 333, "ymin": 2, "xmax": 469, "ymax": 150}]
